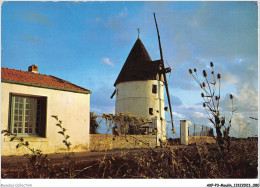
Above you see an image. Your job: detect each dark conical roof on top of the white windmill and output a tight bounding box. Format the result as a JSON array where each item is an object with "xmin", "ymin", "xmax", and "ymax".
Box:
[{"xmin": 114, "ymin": 38, "xmax": 160, "ymax": 86}]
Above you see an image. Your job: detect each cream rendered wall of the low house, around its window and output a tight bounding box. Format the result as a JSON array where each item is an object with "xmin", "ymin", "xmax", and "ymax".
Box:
[{"xmin": 1, "ymin": 82, "xmax": 90, "ymax": 155}]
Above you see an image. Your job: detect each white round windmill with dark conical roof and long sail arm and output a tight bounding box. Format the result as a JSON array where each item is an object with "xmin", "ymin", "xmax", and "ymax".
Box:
[{"xmin": 111, "ymin": 13, "xmax": 174, "ymax": 143}]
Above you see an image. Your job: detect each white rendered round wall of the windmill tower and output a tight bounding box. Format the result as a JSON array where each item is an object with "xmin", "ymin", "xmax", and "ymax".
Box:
[{"xmin": 115, "ymin": 80, "xmax": 166, "ymax": 140}]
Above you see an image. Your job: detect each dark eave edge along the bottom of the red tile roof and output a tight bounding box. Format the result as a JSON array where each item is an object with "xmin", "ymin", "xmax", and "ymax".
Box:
[{"xmin": 1, "ymin": 79, "xmax": 92, "ymax": 94}]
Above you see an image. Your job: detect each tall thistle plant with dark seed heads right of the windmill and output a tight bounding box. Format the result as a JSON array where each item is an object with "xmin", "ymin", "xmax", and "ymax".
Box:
[{"xmin": 189, "ymin": 62, "xmax": 235, "ymax": 151}]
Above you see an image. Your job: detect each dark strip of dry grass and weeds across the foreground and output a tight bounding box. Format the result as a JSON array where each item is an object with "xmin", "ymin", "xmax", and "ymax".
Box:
[{"xmin": 1, "ymin": 139, "xmax": 258, "ymax": 179}]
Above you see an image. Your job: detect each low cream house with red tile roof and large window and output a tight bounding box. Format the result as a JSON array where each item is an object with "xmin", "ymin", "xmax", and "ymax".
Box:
[{"xmin": 1, "ymin": 65, "xmax": 91, "ymax": 155}]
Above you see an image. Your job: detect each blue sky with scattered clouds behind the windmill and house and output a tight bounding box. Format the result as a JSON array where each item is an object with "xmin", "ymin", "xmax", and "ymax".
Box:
[{"xmin": 1, "ymin": 1, "xmax": 258, "ymax": 137}]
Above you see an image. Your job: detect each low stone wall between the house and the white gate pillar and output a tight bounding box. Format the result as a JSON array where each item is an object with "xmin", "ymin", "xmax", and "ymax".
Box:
[{"xmin": 89, "ymin": 134, "xmax": 156, "ymax": 151}]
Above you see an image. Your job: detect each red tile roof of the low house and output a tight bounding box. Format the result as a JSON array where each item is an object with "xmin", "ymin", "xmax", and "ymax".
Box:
[{"xmin": 1, "ymin": 67, "xmax": 91, "ymax": 93}]
